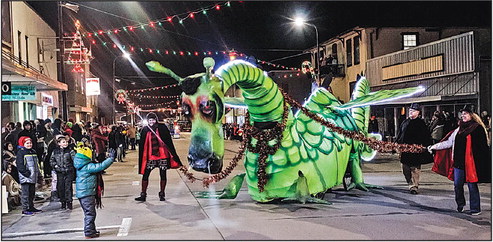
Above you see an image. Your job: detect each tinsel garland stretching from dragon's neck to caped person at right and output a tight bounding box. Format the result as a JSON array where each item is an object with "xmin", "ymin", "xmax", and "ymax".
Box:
[{"xmin": 279, "ymin": 88, "xmax": 426, "ymax": 153}]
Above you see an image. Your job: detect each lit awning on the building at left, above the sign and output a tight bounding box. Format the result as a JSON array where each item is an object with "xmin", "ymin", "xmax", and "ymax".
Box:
[{"xmin": 2, "ymin": 50, "xmax": 68, "ymax": 91}]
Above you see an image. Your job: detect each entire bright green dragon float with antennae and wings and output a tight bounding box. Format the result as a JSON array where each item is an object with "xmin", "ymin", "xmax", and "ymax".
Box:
[{"xmin": 146, "ymin": 58, "xmax": 422, "ymax": 203}]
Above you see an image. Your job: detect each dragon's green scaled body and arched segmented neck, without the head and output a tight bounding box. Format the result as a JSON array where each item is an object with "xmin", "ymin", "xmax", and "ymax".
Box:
[{"xmin": 216, "ymin": 61, "xmax": 364, "ymax": 202}]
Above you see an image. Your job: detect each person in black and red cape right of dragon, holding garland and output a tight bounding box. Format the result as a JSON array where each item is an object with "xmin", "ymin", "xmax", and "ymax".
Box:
[{"xmin": 428, "ymin": 105, "xmax": 491, "ymax": 215}]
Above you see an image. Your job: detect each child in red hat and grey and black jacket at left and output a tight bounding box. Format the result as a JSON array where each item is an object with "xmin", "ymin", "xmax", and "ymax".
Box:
[{"xmin": 16, "ymin": 136, "xmax": 42, "ymax": 215}]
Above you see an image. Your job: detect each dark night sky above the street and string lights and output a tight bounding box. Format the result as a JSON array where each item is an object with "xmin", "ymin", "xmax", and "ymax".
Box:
[{"xmin": 28, "ymin": 1, "xmax": 491, "ymax": 112}]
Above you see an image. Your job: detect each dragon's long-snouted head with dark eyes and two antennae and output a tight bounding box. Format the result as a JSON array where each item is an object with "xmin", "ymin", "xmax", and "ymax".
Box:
[{"xmin": 146, "ymin": 57, "xmax": 224, "ymax": 174}]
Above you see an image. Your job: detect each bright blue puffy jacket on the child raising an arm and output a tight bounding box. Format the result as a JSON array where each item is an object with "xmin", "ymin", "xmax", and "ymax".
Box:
[{"xmin": 74, "ymin": 153, "xmax": 114, "ymax": 198}]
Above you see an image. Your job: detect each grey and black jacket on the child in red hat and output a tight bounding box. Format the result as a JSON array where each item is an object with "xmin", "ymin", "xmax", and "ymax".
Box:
[{"xmin": 16, "ymin": 147, "xmax": 39, "ymax": 184}]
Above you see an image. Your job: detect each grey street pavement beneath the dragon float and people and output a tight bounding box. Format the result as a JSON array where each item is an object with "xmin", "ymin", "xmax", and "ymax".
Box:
[{"xmin": 2, "ymin": 133, "xmax": 492, "ymax": 240}]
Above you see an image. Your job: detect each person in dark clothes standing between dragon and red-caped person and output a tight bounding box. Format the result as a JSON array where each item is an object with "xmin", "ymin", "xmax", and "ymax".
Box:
[{"xmin": 396, "ymin": 103, "xmax": 433, "ymax": 195}]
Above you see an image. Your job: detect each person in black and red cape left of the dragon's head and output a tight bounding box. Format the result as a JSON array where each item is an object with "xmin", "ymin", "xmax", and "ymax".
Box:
[{"xmin": 135, "ymin": 112, "xmax": 182, "ymax": 202}]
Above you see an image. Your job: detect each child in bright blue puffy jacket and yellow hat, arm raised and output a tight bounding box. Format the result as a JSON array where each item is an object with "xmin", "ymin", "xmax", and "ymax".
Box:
[{"xmin": 74, "ymin": 147, "xmax": 115, "ymax": 239}]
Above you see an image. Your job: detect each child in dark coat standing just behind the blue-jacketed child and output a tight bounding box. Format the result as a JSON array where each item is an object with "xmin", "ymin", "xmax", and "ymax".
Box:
[{"xmin": 50, "ymin": 136, "xmax": 75, "ymax": 210}]
